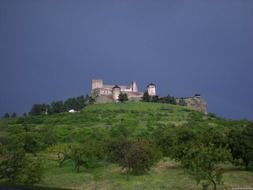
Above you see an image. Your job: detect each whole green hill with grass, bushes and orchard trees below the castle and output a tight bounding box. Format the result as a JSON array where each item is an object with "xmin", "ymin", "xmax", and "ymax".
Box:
[{"xmin": 0, "ymin": 102, "xmax": 253, "ymax": 189}]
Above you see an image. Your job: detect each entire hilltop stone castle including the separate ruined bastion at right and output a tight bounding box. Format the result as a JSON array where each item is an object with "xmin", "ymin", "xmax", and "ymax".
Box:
[{"xmin": 91, "ymin": 79, "xmax": 207, "ymax": 113}]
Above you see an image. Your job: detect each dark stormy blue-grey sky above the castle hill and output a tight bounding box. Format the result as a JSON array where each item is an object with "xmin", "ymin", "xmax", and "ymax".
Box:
[{"xmin": 0, "ymin": 0, "xmax": 253, "ymax": 120}]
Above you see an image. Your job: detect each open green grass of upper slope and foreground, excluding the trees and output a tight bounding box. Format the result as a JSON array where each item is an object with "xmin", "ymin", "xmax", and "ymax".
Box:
[{"xmin": 0, "ymin": 102, "xmax": 253, "ymax": 190}]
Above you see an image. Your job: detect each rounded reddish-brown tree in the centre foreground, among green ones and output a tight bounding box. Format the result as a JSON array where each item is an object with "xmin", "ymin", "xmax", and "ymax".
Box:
[{"xmin": 108, "ymin": 139, "xmax": 161, "ymax": 174}]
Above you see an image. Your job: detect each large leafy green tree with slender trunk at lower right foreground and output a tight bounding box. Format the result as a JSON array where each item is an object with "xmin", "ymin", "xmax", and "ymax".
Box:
[{"xmin": 172, "ymin": 128, "xmax": 230, "ymax": 190}]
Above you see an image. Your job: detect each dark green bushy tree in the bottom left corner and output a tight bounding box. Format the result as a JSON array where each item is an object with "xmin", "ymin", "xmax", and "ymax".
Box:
[{"xmin": 0, "ymin": 134, "xmax": 42, "ymax": 184}]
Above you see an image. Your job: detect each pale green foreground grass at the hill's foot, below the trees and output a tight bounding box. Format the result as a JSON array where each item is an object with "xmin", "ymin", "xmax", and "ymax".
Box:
[{"xmin": 39, "ymin": 160, "xmax": 253, "ymax": 190}]
